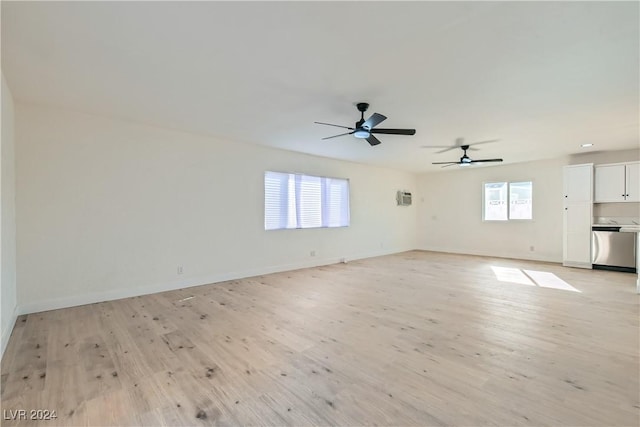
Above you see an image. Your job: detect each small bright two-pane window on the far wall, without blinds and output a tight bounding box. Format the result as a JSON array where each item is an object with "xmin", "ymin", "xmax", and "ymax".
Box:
[{"xmin": 483, "ymin": 181, "xmax": 533, "ymax": 221}]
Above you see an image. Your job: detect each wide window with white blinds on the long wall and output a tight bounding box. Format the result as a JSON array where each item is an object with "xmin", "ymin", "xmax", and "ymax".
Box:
[{"xmin": 264, "ymin": 171, "xmax": 349, "ymax": 230}]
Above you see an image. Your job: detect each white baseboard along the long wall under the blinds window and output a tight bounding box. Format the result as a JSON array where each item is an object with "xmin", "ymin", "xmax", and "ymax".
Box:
[{"xmin": 17, "ymin": 249, "xmax": 412, "ymax": 316}]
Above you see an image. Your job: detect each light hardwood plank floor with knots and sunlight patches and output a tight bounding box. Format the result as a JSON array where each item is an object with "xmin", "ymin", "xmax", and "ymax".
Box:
[{"xmin": 2, "ymin": 251, "xmax": 640, "ymax": 426}]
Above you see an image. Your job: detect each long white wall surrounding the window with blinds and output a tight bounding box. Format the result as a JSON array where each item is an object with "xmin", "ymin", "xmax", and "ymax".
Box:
[{"xmin": 16, "ymin": 103, "xmax": 417, "ymax": 312}]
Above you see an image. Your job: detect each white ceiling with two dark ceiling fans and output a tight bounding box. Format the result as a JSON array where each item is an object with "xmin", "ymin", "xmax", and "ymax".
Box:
[{"xmin": 2, "ymin": 1, "xmax": 640, "ymax": 172}]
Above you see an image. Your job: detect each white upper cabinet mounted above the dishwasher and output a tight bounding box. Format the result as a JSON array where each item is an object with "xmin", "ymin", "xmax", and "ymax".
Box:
[{"xmin": 594, "ymin": 162, "xmax": 640, "ymax": 203}]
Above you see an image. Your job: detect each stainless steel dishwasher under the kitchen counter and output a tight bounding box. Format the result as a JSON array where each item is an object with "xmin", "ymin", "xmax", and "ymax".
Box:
[{"xmin": 591, "ymin": 225, "xmax": 637, "ymax": 273}]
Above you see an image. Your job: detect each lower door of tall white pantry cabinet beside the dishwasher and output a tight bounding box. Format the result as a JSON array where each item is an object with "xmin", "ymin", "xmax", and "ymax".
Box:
[{"xmin": 563, "ymin": 202, "xmax": 592, "ymax": 268}]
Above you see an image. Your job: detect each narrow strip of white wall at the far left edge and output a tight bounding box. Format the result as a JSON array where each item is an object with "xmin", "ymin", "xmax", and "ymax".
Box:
[{"xmin": 0, "ymin": 74, "xmax": 16, "ymax": 356}]
